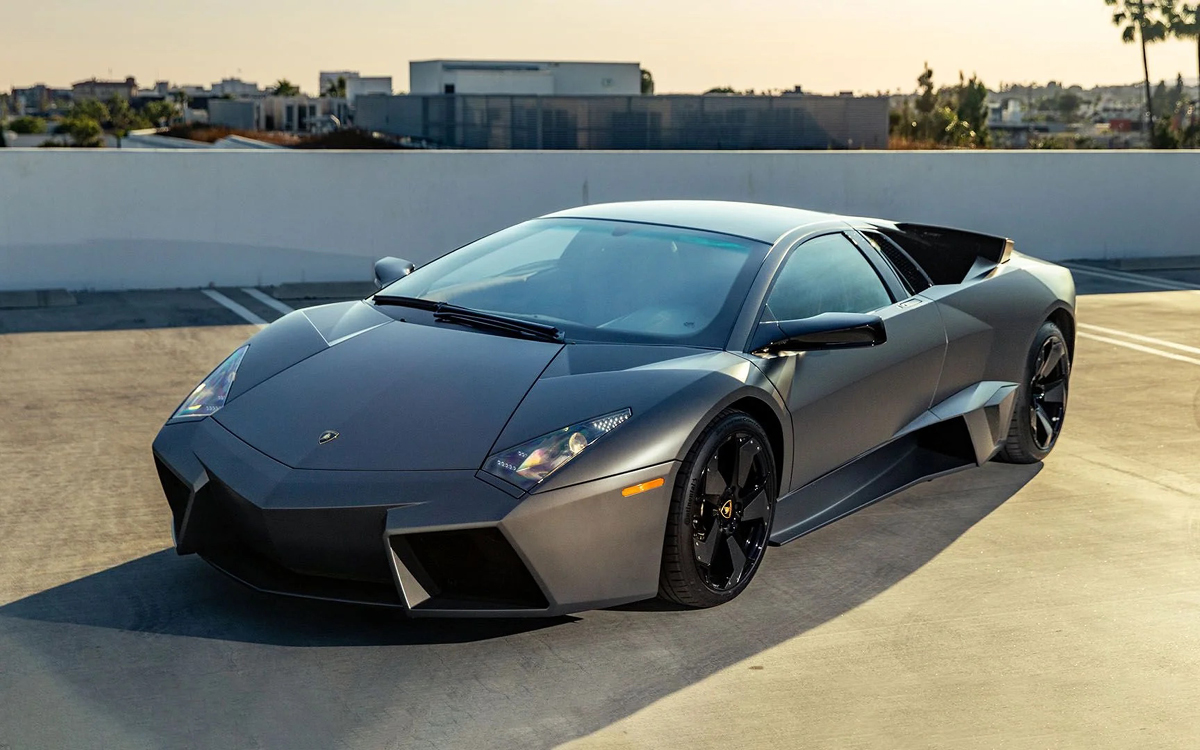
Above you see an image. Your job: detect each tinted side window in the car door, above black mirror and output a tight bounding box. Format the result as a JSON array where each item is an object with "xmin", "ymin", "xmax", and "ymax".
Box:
[{"xmin": 766, "ymin": 234, "xmax": 892, "ymax": 320}]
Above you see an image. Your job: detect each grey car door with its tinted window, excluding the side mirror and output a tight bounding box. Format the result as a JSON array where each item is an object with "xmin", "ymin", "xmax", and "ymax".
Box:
[{"xmin": 761, "ymin": 232, "xmax": 946, "ymax": 491}]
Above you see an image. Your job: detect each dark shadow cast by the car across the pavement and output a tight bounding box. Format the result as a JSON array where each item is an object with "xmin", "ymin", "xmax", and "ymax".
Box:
[{"xmin": 0, "ymin": 464, "xmax": 1040, "ymax": 749}]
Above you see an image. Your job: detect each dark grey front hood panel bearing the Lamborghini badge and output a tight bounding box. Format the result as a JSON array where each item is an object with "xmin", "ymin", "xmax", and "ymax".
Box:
[{"xmin": 214, "ymin": 302, "xmax": 563, "ymax": 470}]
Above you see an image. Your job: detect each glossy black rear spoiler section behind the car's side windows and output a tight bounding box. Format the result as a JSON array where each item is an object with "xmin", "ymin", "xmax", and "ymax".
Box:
[{"xmin": 875, "ymin": 222, "xmax": 1013, "ymax": 284}]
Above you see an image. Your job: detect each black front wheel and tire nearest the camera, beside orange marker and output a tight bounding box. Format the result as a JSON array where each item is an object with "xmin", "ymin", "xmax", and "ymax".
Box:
[{"xmin": 659, "ymin": 409, "xmax": 779, "ymax": 608}]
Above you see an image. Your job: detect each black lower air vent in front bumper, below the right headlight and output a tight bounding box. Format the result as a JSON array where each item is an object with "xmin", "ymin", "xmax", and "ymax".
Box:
[{"xmin": 390, "ymin": 528, "xmax": 548, "ymax": 610}]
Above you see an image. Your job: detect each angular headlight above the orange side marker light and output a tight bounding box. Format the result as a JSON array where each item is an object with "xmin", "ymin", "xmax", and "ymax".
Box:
[{"xmin": 484, "ymin": 409, "xmax": 632, "ymax": 492}]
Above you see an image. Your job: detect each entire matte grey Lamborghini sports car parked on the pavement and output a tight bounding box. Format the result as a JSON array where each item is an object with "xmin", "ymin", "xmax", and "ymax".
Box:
[{"xmin": 154, "ymin": 202, "xmax": 1075, "ymax": 616}]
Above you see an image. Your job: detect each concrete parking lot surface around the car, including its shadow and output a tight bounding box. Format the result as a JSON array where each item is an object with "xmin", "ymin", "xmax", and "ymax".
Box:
[{"xmin": 0, "ymin": 268, "xmax": 1200, "ymax": 749}]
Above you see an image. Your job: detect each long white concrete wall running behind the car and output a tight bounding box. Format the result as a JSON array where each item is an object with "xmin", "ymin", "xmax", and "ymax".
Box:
[{"xmin": 0, "ymin": 149, "xmax": 1200, "ymax": 289}]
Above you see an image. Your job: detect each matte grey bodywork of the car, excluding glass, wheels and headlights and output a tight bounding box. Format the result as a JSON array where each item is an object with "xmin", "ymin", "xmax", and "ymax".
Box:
[{"xmin": 154, "ymin": 202, "xmax": 1074, "ymax": 617}]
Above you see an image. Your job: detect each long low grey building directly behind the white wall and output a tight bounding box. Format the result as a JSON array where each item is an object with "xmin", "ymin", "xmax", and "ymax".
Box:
[{"xmin": 354, "ymin": 95, "xmax": 888, "ymax": 150}]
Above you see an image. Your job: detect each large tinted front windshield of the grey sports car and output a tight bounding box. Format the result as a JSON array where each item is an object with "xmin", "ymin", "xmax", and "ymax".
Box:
[{"xmin": 379, "ymin": 218, "xmax": 768, "ymax": 348}]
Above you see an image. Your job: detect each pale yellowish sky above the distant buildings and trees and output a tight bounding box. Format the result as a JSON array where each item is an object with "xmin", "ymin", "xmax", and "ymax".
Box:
[{"xmin": 7, "ymin": 0, "xmax": 1196, "ymax": 94}]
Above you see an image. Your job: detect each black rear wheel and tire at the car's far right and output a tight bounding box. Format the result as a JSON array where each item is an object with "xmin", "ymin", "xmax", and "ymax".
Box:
[{"xmin": 997, "ymin": 322, "xmax": 1070, "ymax": 463}]
